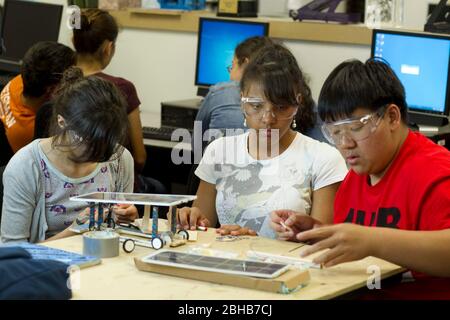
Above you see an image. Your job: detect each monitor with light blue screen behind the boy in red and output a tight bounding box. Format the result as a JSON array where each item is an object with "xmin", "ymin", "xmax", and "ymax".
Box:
[{"xmin": 372, "ymin": 29, "xmax": 450, "ymax": 126}]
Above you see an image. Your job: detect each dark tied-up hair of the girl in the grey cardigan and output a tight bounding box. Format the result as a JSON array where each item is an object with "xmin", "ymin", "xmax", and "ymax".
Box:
[{"xmin": 52, "ymin": 67, "xmax": 128, "ymax": 163}]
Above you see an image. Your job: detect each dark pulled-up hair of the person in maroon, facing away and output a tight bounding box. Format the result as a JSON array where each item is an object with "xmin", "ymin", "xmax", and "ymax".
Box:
[{"xmin": 73, "ymin": 9, "xmax": 119, "ymax": 54}]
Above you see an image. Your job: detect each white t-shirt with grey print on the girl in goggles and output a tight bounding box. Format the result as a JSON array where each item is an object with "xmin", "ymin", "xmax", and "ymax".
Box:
[{"xmin": 195, "ymin": 132, "xmax": 347, "ymax": 238}]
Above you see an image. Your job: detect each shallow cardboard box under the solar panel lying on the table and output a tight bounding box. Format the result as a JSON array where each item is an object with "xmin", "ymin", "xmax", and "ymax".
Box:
[{"xmin": 134, "ymin": 257, "xmax": 310, "ymax": 293}]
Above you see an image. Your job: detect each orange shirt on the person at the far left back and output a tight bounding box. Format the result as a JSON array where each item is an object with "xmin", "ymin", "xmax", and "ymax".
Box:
[{"xmin": 0, "ymin": 75, "xmax": 36, "ymax": 152}]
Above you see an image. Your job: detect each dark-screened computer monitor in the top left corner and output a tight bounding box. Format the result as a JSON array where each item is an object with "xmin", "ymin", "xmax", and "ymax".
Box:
[{"xmin": 0, "ymin": 0, "xmax": 63, "ymax": 72}]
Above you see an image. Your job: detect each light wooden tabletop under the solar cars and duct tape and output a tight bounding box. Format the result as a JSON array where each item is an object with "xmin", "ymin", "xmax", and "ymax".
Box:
[{"xmin": 45, "ymin": 225, "xmax": 403, "ymax": 300}]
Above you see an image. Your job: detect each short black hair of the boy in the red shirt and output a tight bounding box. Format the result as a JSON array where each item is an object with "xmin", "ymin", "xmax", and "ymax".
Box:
[{"xmin": 318, "ymin": 59, "xmax": 408, "ymax": 123}]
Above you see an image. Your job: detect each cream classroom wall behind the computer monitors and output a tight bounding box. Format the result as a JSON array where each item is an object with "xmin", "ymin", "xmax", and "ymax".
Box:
[{"xmin": 13, "ymin": 0, "xmax": 438, "ymax": 112}]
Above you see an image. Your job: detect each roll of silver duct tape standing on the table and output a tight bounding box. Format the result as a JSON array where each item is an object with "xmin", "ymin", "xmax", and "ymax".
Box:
[{"xmin": 83, "ymin": 231, "xmax": 119, "ymax": 258}]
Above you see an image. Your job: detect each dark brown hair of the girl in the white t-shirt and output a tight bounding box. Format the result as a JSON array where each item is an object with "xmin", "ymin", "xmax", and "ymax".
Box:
[{"xmin": 241, "ymin": 43, "xmax": 316, "ymax": 133}]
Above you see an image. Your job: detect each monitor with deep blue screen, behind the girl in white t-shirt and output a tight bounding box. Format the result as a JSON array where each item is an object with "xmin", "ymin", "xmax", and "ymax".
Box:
[{"xmin": 195, "ymin": 18, "xmax": 269, "ymax": 95}]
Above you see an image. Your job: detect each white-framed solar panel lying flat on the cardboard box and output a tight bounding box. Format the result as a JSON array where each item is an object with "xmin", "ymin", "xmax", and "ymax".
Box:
[{"xmin": 142, "ymin": 250, "xmax": 289, "ymax": 278}]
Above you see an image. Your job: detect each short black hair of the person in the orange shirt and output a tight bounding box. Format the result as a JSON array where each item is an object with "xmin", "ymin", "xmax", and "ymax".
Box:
[{"xmin": 21, "ymin": 41, "xmax": 76, "ymax": 98}]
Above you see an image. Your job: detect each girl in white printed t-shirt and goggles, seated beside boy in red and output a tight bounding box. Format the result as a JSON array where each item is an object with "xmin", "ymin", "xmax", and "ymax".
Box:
[{"xmin": 178, "ymin": 44, "xmax": 347, "ymax": 238}]
